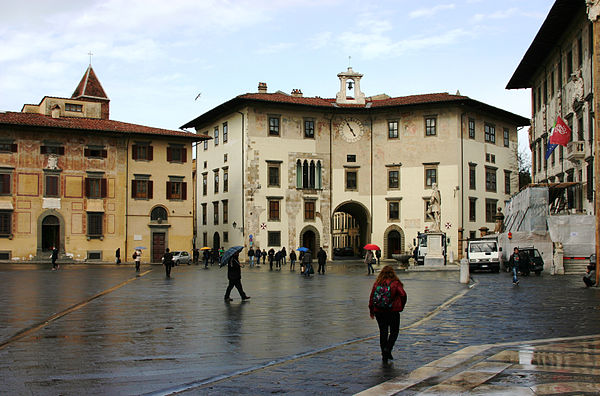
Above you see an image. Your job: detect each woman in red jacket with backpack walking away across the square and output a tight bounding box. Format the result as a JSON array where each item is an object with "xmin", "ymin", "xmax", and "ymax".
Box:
[{"xmin": 369, "ymin": 265, "xmax": 406, "ymax": 363}]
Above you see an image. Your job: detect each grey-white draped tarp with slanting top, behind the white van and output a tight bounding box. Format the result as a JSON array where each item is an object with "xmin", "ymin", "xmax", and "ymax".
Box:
[{"xmin": 504, "ymin": 187, "xmax": 548, "ymax": 234}]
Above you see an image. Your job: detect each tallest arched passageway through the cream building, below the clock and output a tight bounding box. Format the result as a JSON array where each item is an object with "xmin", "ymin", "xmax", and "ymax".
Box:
[{"xmin": 331, "ymin": 201, "xmax": 371, "ymax": 255}]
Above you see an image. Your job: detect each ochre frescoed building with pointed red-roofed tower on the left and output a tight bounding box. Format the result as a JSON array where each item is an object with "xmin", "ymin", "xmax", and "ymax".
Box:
[{"xmin": 0, "ymin": 66, "xmax": 203, "ymax": 261}]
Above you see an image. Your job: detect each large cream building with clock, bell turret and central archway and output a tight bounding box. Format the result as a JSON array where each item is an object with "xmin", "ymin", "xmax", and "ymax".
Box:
[{"xmin": 182, "ymin": 68, "xmax": 529, "ymax": 258}]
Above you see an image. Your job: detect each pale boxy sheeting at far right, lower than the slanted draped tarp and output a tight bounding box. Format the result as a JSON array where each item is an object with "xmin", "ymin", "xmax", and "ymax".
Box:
[{"xmin": 547, "ymin": 215, "xmax": 596, "ymax": 257}]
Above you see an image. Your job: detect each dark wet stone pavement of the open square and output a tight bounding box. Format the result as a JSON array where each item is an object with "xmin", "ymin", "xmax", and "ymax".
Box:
[{"xmin": 0, "ymin": 263, "xmax": 600, "ymax": 395}]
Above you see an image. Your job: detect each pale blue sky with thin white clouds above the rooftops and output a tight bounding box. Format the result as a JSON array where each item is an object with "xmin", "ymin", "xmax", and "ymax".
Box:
[{"xmin": 0, "ymin": 0, "xmax": 554, "ymax": 158}]
